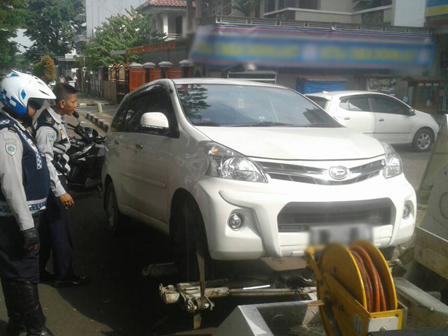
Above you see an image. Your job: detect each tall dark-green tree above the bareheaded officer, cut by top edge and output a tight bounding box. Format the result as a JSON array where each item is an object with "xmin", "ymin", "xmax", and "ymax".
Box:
[{"xmin": 25, "ymin": 0, "xmax": 83, "ymax": 62}]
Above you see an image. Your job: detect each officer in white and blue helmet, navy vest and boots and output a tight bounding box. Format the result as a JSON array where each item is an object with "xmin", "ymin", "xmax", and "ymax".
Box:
[{"xmin": 0, "ymin": 71, "xmax": 54, "ymax": 336}]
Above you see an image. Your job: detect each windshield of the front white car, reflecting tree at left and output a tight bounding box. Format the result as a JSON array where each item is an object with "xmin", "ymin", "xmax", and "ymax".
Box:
[{"xmin": 177, "ymin": 84, "xmax": 341, "ymax": 127}]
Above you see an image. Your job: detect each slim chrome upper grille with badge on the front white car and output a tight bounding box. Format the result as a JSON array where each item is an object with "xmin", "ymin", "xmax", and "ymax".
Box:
[{"xmin": 257, "ymin": 160, "xmax": 385, "ymax": 185}]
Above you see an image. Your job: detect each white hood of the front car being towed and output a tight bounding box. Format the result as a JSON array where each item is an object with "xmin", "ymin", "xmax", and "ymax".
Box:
[{"xmin": 197, "ymin": 127, "xmax": 384, "ymax": 160}]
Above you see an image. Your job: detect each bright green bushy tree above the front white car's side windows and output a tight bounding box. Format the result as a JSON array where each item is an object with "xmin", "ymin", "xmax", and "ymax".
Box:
[{"xmin": 84, "ymin": 7, "xmax": 164, "ymax": 68}]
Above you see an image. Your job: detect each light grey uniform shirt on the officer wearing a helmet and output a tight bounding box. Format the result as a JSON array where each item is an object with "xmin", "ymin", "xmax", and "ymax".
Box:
[{"xmin": 0, "ymin": 112, "xmax": 40, "ymax": 231}]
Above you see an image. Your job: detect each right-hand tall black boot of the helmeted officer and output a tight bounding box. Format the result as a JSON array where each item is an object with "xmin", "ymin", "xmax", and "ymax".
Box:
[{"xmin": 11, "ymin": 281, "xmax": 54, "ymax": 336}]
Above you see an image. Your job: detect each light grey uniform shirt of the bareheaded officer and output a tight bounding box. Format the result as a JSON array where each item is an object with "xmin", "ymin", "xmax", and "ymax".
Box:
[{"xmin": 36, "ymin": 107, "xmax": 70, "ymax": 197}]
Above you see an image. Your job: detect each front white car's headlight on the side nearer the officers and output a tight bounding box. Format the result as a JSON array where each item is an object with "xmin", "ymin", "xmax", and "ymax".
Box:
[{"xmin": 200, "ymin": 142, "xmax": 268, "ymax": 183}]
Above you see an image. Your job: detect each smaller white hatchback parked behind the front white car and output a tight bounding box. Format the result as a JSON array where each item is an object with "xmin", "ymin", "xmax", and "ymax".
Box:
[{"xmin": 306, "ymin": 91, "xmax": 439, "ymax": 152}]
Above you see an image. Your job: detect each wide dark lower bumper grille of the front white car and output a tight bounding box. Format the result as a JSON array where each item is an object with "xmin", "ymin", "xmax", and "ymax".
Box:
[{"xmin": 277, "ymin": 198, "xmax": 395, "ymax": 232}]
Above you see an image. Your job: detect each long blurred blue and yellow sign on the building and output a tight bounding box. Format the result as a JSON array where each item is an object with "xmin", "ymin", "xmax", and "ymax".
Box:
[{"xmin": 190, "ymin": 26, "xmax": 434, "ymax": 69}]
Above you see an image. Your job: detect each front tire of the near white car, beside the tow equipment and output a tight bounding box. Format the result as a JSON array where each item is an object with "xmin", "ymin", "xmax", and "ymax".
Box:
[{"xmin": 171, "ymin": 197, "xmax": 212, "ymax": 281}]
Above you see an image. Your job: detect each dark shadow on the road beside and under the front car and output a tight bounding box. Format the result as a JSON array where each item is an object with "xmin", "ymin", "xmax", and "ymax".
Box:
[{"xmin": 54, "ymin": 193, "xmax": 245, "ymax": 336}]
